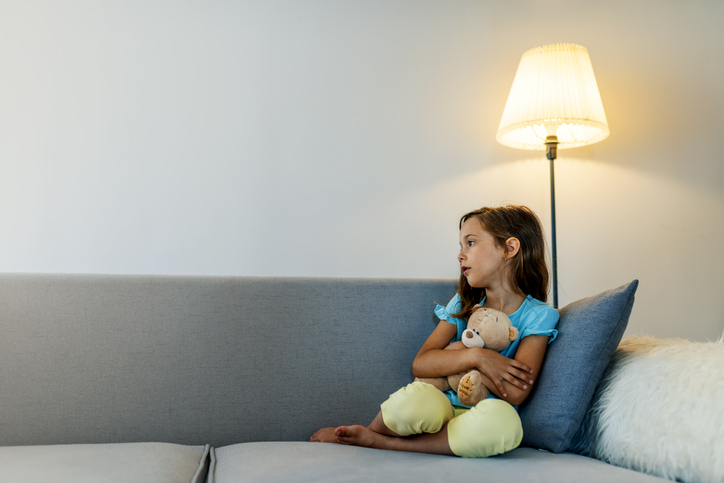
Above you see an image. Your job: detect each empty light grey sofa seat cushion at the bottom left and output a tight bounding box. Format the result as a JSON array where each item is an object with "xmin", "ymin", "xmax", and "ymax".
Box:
[{"xmin": 0, "ymin": 443, "xmax": 210, "ymax": 483}]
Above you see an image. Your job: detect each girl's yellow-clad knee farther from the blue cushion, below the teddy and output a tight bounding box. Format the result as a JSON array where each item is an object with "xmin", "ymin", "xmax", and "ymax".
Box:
[{"xmin": 381, "ymin": 381, "xmax": 453, "ymax": 436}]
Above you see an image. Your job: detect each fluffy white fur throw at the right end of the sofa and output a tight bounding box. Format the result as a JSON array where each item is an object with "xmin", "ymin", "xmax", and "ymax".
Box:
[{"xmin": 571, "ymin": 337, "xmax": 724, "ymax": 482}]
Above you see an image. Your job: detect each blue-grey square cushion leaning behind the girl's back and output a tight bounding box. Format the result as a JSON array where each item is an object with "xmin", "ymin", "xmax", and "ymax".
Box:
[{"xmin": 520, "ymin": 280, "xmax": 638, "ymax": 453}]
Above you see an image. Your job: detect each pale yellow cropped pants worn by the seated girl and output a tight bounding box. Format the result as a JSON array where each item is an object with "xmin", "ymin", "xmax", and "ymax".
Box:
[{"xmin": 381, "ymin": 381, "xmax": 523, "ymax": 458}]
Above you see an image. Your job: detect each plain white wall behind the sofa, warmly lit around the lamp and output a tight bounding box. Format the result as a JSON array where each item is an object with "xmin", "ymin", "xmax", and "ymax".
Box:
[{"xmin": 0, "ymin": 0, "xmax": 724, "ymax": 340}]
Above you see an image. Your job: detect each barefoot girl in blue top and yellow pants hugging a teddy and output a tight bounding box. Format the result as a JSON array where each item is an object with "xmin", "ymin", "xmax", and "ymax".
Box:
[{"xmin": 310, "ymin": 206, "xmax": 558, "ymax": 457}]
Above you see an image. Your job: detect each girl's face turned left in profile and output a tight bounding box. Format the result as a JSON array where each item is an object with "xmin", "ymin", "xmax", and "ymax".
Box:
[{"xmin": 458, "ymin": 218, "xmax": 506, "ymax": 288}]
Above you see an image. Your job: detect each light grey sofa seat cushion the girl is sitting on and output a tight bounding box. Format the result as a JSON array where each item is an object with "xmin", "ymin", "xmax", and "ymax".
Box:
[{"xmin": 208, "ymin": 442, "xmax": 665, "ymax": 483}]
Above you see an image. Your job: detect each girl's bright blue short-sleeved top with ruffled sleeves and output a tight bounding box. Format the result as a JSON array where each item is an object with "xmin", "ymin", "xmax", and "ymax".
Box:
[{"xmin": 435, "ymin": 294, "xmax": 559, "ymax": 407}]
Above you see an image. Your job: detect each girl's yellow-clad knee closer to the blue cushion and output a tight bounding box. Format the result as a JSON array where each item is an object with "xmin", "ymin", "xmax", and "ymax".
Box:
[{"xmin": 447, "ymin": 399, "xmax": 523, "ymax": 458}]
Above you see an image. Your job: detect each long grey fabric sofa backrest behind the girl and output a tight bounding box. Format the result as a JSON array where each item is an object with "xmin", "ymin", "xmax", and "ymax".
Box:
[{"xmin": 0, "ymin": 274, "xmax": 456, "ymax": 446}]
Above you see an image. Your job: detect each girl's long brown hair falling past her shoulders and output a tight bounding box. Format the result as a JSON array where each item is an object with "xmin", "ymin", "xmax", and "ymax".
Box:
[{"xmin": 455, "ymin": 205, "xmax": 548, "ymax": 319}]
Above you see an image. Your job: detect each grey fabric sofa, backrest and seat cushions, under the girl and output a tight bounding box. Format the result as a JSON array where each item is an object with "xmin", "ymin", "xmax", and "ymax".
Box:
[{"xmin": 0, "ymin": 274, "xmax": 659, "ymax": 483}]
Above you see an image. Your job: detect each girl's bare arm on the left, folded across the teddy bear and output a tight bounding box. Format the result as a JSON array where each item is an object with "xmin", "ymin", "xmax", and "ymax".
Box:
[{"xmin": 412, "ymin": 321, "xmax": 536, "ymax": 396}]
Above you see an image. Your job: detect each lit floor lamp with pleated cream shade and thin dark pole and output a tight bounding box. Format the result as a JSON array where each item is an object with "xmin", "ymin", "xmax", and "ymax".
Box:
[{"xmin": 496, "ymin": 44, "xmax": 608, "ymax": 308}]
